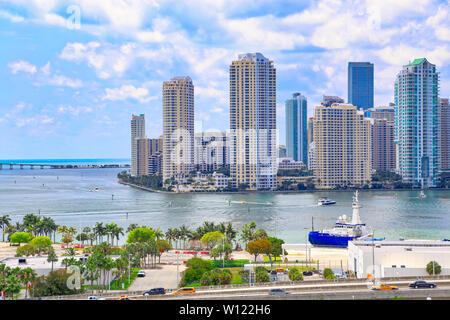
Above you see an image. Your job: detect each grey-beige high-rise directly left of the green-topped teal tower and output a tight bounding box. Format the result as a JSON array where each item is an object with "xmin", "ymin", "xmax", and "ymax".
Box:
[{"xmin": 364, "ymin": 106, "xmax": 395, "ymax": 171}]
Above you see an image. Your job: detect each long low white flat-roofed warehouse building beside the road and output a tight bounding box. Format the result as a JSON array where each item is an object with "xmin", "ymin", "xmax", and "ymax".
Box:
[{"xmin": 348, "ymin": 240, "xmax": 450, "ymax": 278}]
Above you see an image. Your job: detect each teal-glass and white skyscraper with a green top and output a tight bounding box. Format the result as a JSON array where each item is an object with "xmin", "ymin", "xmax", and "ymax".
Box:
[{"xmin": 394, "ymin": 58, "xmax": 439, "ymax": 187}]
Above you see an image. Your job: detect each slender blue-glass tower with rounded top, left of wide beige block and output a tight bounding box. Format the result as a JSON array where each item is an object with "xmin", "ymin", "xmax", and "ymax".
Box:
[{"xmin": 285, "ymin": 93, "xmax": 308, "ymax": 166}]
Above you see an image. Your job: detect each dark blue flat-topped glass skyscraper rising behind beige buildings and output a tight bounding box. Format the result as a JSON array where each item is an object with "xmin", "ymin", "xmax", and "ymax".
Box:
[{"xmin": 348, "ymin": 62, "xmax": 373, "ymax": 110}]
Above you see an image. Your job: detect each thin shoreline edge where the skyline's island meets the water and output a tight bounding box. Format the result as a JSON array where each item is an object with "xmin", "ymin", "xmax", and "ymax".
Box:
[{"xmin": 118, "ymin": 179, "xmax": 450, "ymax": 194}]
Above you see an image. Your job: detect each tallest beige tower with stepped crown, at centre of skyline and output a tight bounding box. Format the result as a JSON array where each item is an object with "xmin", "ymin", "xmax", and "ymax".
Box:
[{"xmin": 230, "ymin": 53, "xmax": 277, "ymax": 190}]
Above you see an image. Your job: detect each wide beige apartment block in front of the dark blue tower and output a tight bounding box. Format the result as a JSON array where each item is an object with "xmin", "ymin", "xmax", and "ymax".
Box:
[{"xmin": 313, "ymin": 104, "xmax": 372, "ymax": 188}]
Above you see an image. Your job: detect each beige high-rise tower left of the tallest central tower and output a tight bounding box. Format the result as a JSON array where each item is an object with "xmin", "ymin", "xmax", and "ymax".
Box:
[{"xmin": 162, "ymin": 77, "xmax": 194, "ymax": 181}]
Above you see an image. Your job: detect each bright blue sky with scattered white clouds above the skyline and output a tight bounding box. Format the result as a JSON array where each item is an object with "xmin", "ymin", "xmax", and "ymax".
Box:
[{"xmin": 0, "ymin": 0, "xmax": 450, "ymax": 159}]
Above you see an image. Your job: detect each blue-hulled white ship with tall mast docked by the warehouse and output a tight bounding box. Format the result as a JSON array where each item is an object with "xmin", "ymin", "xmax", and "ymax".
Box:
[{"xmin": 308, "ymin": 191, "xmax": 372, "ymax": 248}]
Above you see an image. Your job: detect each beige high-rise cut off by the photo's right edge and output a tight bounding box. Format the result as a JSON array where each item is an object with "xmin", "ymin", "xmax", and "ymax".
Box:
[{"xmin": 439, "ymin": 98, "xmax": 450, "ymax": 171}]
